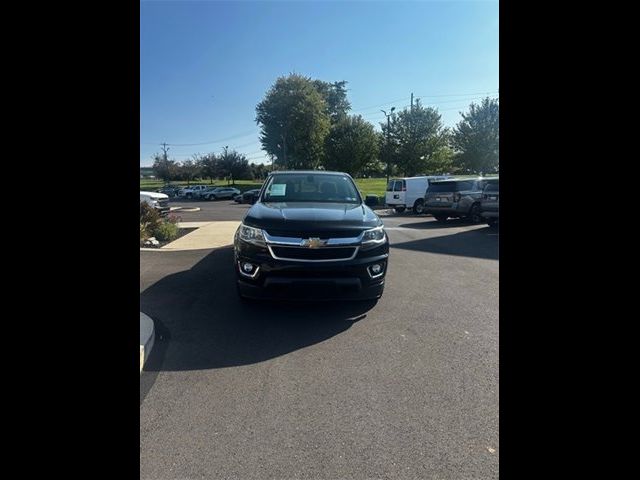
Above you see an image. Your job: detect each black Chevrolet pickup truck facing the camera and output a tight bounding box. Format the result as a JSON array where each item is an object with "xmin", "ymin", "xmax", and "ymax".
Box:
[{"xmin": 234, "ymin": 171, "xmax": 389, "ymax": 300}]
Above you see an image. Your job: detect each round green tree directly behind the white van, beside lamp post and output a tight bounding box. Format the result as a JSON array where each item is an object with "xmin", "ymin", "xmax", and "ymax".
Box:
[{"xmin": 383, "ymin": 99, "xmax": 449, "ymax": 176}]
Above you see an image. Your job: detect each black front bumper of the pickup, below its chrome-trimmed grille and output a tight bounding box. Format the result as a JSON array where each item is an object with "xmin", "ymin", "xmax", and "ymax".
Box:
[{"xmin": 234, "ymin": 239, "xmax": 389, "ymax": 300}]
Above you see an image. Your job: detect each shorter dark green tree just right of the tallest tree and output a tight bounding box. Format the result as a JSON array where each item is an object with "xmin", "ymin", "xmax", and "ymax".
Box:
[{"xmin": 323, "ymin": 115, "xmax": 378, "ymax": 177}]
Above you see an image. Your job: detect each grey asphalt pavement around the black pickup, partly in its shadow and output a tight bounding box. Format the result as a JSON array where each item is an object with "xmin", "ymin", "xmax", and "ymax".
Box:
[{"xmin": 140, "ymin": 200, "xmax": 499, "ymax": 480}]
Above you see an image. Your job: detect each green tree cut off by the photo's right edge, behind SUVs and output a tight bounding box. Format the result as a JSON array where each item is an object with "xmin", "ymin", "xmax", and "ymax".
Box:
[{"xmin": 452, "ymin": 97, "xmax": 500, "ymax": 173}]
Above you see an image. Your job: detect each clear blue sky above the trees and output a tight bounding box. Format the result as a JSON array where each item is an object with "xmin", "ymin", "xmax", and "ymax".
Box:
[{"xmin": 140, "ymin": 0, "xmax": 499, "ymax": 166}]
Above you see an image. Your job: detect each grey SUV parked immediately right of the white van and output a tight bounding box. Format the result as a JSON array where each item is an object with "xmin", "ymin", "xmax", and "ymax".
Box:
[{"xmin": 424, "ymin": 178, "xmax": 489, "ymax": 223}]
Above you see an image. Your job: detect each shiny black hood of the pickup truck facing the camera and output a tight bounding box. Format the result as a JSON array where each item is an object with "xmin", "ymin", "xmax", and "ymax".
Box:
[{"xmin": 243, "ymin": 202, "xmax": 382, "ymax": 234}]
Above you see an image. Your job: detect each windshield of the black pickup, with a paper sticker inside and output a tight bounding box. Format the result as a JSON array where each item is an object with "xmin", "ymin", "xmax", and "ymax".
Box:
[{"xmin": 262, "ymin": 173, "xmax": 361, "ymax": 203}]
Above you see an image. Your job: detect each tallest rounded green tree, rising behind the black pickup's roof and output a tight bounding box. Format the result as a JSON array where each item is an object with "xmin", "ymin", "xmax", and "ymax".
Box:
[{"xmin": 256, "ymin": 74, "xmax": 330, "ymax": 169}]
